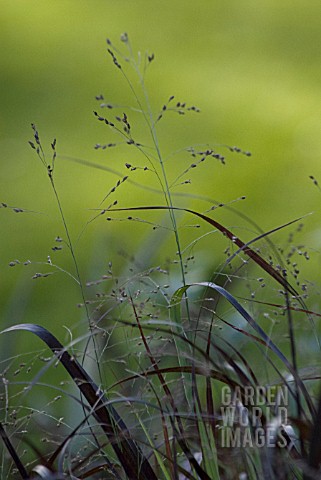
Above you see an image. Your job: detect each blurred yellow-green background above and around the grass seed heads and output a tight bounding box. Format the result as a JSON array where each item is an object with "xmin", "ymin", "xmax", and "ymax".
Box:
[{"xmin": 0, "ymin": 0, "xmax": 321, "ymax": 342}]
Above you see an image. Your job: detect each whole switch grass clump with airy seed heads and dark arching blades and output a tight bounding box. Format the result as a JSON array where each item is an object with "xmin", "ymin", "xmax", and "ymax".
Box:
[{"xmin": 0, "ymin": 34, "xmax": 321, "ymax": 480}]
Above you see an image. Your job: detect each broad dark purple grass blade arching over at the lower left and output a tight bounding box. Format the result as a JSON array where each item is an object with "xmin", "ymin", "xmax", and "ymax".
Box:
[{"xmin": 1, "ymin": 323, "xmax": 157, "ymax": 480}]
